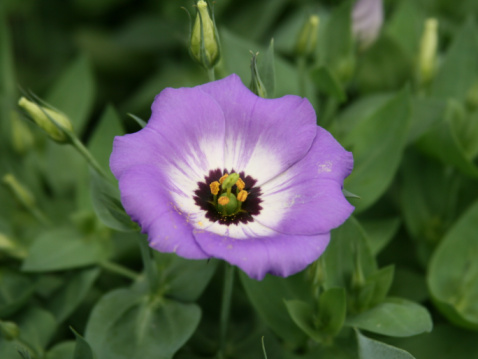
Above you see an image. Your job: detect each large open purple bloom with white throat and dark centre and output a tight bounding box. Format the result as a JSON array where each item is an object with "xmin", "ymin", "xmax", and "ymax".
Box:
[{"xmin": 110, "ymin": 75, "xmax": 353, "ymax": 279}]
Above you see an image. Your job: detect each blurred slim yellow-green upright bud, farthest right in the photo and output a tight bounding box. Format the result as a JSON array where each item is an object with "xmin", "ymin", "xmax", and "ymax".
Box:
[{"xmin": 418, "ymin": 19, "xmax": 438, "ymax": 84}]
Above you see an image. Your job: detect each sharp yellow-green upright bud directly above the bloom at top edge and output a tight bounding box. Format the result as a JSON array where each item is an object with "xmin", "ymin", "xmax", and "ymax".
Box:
[{"xmin": 189, "ymin": 0, "xmax": 219, "ymax": 70}]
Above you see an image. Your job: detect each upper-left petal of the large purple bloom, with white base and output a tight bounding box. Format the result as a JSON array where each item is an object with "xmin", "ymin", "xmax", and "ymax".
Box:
[{"xmin": 110, "ymin": 87, "xmax": 225, "ymax": 222}]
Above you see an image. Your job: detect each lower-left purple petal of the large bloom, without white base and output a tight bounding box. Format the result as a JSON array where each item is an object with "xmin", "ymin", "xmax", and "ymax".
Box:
[{"xmin": 119, "ymin": 165, "xmax": 209, "ymax": 259}]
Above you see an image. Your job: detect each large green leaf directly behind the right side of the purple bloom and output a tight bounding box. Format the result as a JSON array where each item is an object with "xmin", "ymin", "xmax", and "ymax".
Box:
[{"xmin": 342, "ymin": 89, "xmax": 410, "ymax": 212}]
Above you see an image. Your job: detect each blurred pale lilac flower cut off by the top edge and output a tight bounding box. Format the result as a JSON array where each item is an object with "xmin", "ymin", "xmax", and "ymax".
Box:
[{"xmin": 352, "ymin": 0, "xmax": 383, "ymax": 48}]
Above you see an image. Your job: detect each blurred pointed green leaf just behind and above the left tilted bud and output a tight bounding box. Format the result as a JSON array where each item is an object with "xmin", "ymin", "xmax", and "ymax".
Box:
[{"xmin": 46, "ymin": 56, "xmax": 95, "ymax": 135}]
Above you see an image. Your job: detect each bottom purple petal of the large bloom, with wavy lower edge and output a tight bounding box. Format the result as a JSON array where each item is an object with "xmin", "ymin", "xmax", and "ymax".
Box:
[{"xmin": 194, "ymin": 230, "xmax": 330, "ymax": 280}]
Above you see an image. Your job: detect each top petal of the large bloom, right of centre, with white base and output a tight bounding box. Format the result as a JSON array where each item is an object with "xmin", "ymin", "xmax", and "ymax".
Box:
[{"xmin": 199, "ymin": 75, "xmax": 317, "ymax": 186}]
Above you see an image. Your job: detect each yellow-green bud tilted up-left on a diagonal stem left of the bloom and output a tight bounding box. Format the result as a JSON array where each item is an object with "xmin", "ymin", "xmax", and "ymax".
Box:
[{"xmin": 18, "ymin": 97, "xmax": 73, "ymax": 143}]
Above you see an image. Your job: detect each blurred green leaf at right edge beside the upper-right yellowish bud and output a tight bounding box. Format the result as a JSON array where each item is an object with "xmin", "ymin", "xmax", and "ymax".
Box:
[{"xmin": 431, "ymin": 19, "xmax": 478, "ymax": 101}]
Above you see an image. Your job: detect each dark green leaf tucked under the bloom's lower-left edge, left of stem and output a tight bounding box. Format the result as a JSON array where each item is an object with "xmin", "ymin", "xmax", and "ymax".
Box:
[{"xmin": 154, "ymin": 251, "xmax": 218, "ymax": 302}]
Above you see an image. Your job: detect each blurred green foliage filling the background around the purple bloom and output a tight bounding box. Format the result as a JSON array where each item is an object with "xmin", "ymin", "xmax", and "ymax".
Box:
[{"xmin": 0, "ymin": 0, "xmax": 478, "ymax": 359}]
